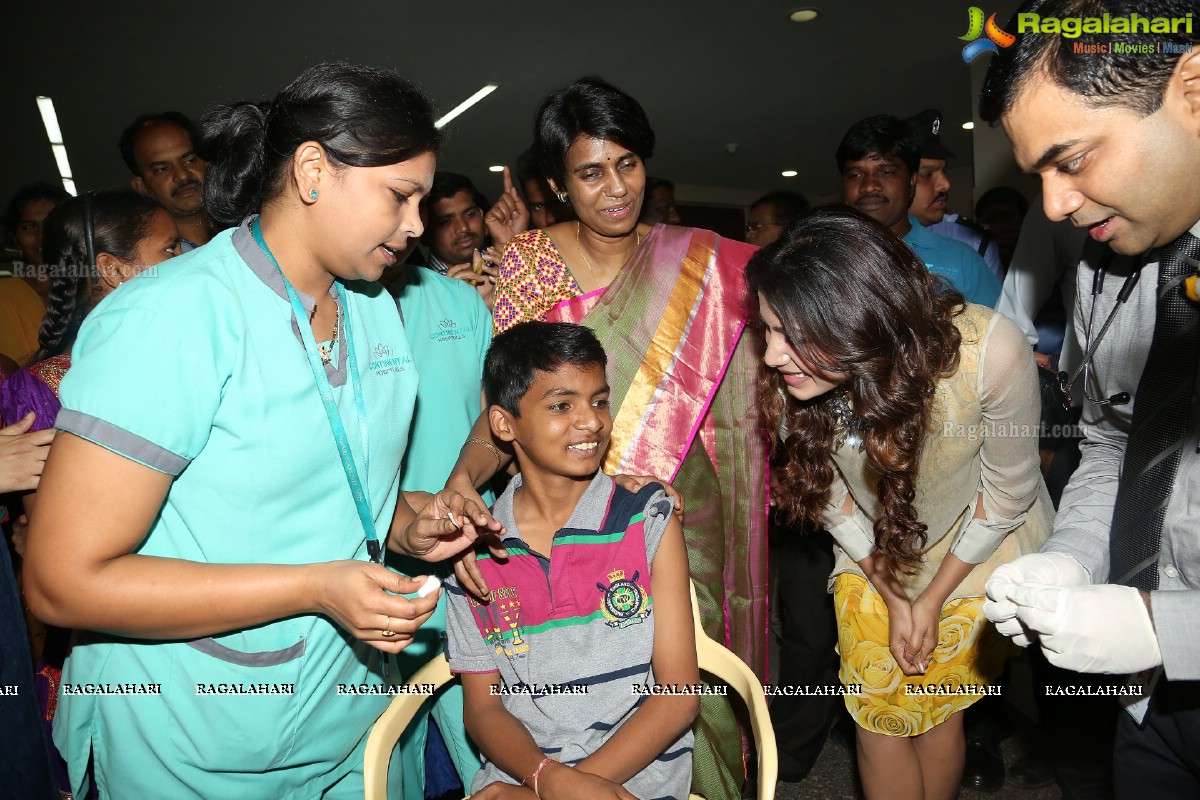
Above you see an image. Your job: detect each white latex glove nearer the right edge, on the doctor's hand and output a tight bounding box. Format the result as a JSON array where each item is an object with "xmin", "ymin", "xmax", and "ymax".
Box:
[{"xmin": 1008, "ymin": 584, "xmax": 1163, "ymax": 675}]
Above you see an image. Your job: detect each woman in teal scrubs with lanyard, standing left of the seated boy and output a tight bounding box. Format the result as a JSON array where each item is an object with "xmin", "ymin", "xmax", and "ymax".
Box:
[{"xmin": 25, "ymin": 65, "xmax": 499, "ymax": 799}]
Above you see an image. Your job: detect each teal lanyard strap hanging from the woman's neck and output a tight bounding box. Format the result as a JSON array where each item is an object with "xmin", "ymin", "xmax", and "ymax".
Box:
[{"xmin": 250, "ymin": 219, "xmax": 383, "ymax": 564}]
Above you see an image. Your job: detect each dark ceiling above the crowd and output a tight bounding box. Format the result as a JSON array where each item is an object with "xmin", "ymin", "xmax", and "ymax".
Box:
[{"xmin": 0, "ymin": 0, "xmax": 1016, "ymax": 209}]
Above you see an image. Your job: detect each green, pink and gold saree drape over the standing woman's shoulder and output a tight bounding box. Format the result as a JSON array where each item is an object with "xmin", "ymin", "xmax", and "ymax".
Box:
[{"xmin": 545, "ymin": 225, "xmax": 767, "ymax": 674}]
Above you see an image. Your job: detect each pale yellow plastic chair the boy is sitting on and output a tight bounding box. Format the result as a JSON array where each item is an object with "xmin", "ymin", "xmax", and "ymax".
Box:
[{"xmin": 362, "ymin": 587, "xmax": 779, "ymax": 800}]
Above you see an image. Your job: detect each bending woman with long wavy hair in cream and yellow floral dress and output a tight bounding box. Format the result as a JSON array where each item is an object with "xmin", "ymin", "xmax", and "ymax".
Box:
[{"xmin": 746, "ymin": 209, "xmax": 1052, "ymax": 800}]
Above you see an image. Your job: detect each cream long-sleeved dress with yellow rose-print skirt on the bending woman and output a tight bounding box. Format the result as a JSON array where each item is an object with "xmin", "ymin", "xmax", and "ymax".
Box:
[{"xmin": 826, "ymin": 305, "xmax": 1054, "ymax": 736}]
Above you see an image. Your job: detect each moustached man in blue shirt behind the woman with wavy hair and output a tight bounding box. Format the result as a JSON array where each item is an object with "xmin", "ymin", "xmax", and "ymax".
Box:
[{"xmin": 836, "ymin": 114, "xmax": 1000, "ymax": 308}]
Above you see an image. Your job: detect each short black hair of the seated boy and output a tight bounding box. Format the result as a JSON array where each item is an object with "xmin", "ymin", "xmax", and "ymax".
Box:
[{"xmin": 484, "ymin": 321, "xmax": 608, "ymax": 419}]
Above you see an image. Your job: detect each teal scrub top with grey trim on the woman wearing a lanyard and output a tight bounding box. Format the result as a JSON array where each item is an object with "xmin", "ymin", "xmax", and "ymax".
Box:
[{"xmin": 55, "ymin": 220, "xmax": 418, "ymax": 799}]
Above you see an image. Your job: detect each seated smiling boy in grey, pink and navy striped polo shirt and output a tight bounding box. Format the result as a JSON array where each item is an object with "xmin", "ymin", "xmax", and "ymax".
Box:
[{"xmin": 446, "ymin": 321, "xmax": 700, "ymax": 800}]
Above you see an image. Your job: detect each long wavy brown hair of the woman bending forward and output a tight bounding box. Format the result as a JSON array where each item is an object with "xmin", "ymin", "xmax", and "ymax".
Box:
[{"xmin": 746, "ymin": 206, "xmax": 965, "ymax": 573}]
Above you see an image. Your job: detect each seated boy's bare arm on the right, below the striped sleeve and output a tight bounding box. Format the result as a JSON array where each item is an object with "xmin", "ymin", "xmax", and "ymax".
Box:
[{"xmin": 576, "ymin": 516, "xmax": 700, "ymax": 783}]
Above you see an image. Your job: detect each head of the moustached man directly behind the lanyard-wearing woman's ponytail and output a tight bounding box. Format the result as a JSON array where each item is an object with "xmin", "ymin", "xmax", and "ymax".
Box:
[{"xmin": 118, "ymin": 112, "xmax": 214, "ymax": 253}]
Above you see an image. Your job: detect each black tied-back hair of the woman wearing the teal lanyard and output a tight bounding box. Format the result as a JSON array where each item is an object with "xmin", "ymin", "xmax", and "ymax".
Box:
[{"xmin": 202, "ymin": 62, "xmax": 442, "ymax": 228}]
